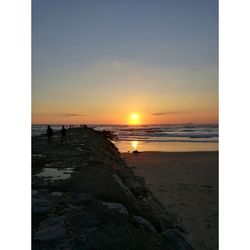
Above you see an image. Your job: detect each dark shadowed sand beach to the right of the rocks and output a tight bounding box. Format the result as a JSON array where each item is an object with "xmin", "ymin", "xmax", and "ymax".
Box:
[{"xmin": 123, "ymin": 152, "xmax": 218, "ymax": 250}]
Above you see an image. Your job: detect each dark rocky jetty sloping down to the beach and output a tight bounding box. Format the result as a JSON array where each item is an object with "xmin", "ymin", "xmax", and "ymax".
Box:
[{"xmin": 32, "ymin": 127, "xmax": 193, "ymax": 250}]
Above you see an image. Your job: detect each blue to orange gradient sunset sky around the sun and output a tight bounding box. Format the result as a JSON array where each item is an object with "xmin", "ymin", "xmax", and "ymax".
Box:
[{"xmin": 32, "ymin": 0, "xmax": 218, "ymax": 124}]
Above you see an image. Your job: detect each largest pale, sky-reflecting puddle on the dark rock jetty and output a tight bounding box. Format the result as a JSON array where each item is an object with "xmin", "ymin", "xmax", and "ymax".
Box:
[{"xmin": 36, "ymin": 168, "xmax": 73, "ymax": 180}]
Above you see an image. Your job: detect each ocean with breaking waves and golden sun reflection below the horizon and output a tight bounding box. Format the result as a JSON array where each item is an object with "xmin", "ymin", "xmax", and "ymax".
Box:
[{"xmin": 32, "ymin": 124, "xmax": 219, "ymax": 152}]
